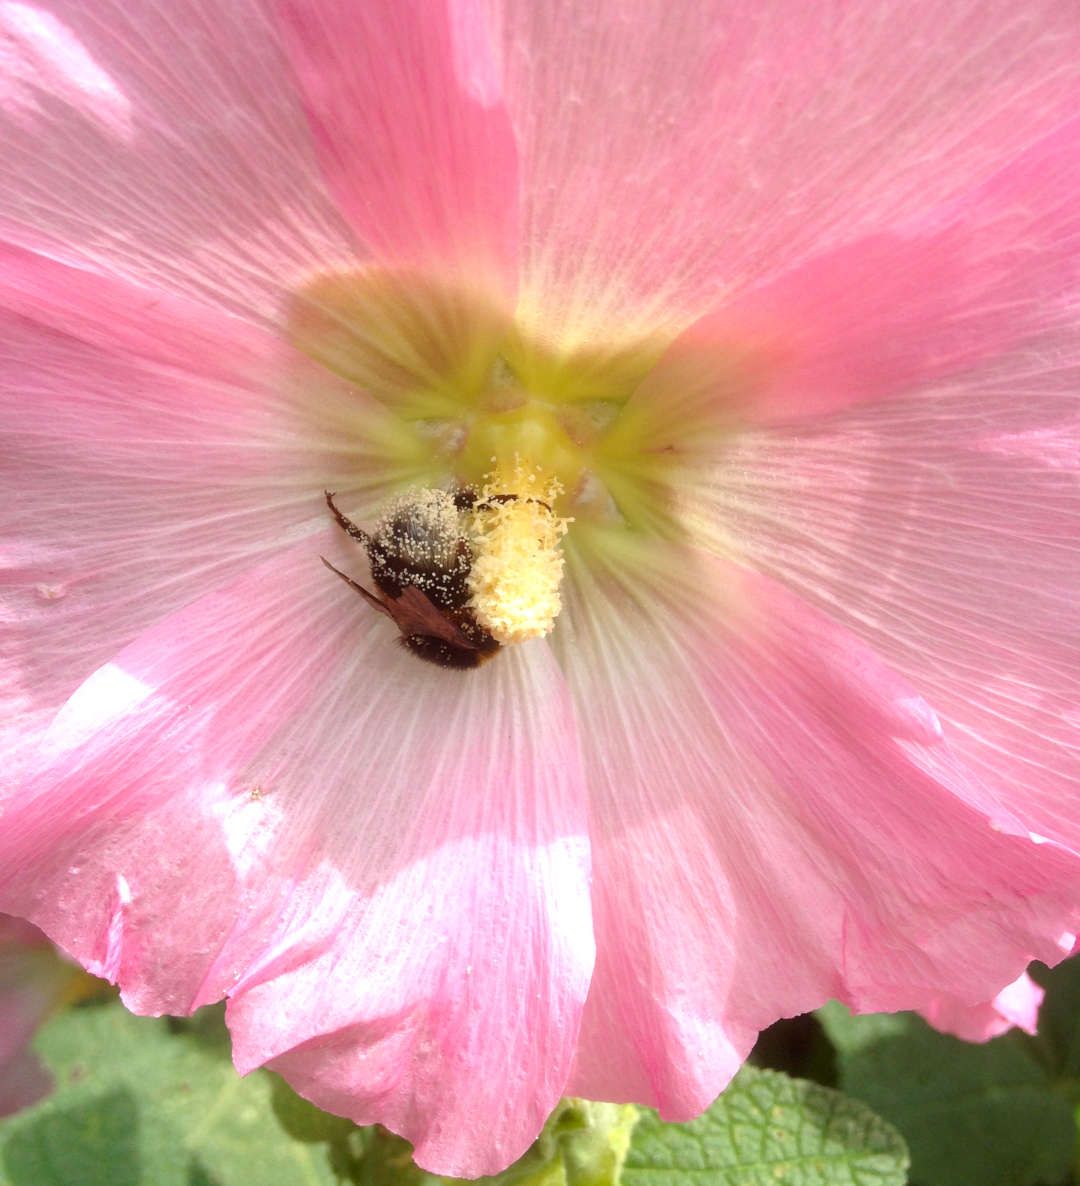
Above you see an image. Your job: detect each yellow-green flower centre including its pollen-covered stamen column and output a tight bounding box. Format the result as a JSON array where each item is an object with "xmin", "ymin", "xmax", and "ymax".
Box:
[{"xmin": 287, "ymin": 267, "xmax": 729, "ymax": 643}]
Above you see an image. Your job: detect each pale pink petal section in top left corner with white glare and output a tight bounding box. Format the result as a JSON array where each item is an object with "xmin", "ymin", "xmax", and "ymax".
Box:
[{"xmin": 0, "ymin": 0, "xmax": 357, "ymax": 318}]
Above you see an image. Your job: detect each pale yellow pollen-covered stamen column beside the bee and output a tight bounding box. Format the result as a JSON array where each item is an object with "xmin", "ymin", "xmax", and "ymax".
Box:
[{"xmin": 468, "ymin": 460, "xmax": 569, "ymax": 644}]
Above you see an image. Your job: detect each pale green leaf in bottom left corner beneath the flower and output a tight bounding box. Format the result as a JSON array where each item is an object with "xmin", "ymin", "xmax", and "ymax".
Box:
[{"xmin": 0, "ymin": 1001, "xmax": 346, "ymax": 1186}]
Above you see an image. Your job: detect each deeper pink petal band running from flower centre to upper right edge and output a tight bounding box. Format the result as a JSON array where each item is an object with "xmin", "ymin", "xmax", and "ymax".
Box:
[{"xmin": 635, "ymin": 112, "xmax": 1080, "ymax": 447}]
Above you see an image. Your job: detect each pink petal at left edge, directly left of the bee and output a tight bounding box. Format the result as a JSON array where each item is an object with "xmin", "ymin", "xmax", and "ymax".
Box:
[{"xmin": 0, "ymin": 248, "xmax": 405, "ymax": 782}]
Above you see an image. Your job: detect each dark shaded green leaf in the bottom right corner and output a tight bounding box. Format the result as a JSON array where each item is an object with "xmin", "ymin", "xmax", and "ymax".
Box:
[{"xmin": 818, "ymin": 1002, "xmax": 1075, "ymax": 1186}]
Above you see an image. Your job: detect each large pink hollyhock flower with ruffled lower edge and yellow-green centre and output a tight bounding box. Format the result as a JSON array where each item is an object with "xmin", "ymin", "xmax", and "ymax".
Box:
[{"xmin": 0, "ymin": 0, "xmax": 1080, "ymax": 1175}]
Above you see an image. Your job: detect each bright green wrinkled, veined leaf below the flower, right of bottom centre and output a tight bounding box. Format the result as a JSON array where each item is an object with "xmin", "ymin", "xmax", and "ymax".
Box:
[{"xmin": 622, "ymin": 1066, "xmax": 908, "ymax": 1186}]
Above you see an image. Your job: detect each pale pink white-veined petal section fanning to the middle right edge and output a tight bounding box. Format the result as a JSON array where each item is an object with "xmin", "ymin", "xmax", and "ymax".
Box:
[{"xmin": 706, "ymin": 332, "xmax": 1080, "ymax": 852}]
